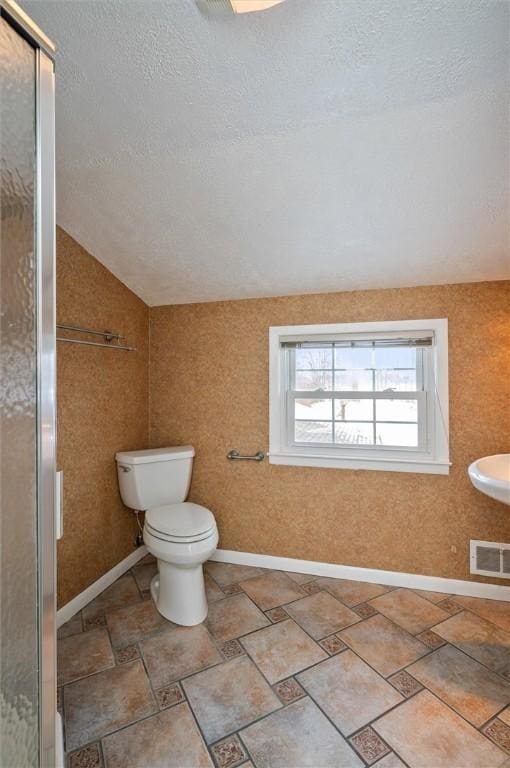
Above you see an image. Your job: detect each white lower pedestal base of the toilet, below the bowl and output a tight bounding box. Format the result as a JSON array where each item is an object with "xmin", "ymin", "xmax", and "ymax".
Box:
[{"xmin": 150, "ymin": 560, "xmax": 208, "ymax": 627}]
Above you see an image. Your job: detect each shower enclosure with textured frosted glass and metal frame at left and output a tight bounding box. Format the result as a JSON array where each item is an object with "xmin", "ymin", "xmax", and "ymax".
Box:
[{"xmin": 0, "ymin": 0, "xmax": 56, "ymax": 768}]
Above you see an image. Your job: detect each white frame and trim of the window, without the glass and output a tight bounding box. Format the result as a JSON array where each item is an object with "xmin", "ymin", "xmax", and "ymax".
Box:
[{"xmin": 269, "ymin": 318, "xmax": 450, "ymax": 475}]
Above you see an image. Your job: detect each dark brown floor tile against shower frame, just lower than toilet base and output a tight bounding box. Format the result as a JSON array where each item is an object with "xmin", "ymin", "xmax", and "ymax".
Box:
[{"xmin": 57, "ymin": 628, "xmax": 115, "ymax": 685}]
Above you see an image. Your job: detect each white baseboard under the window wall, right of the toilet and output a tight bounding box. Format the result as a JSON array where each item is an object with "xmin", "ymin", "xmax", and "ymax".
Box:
[{"xmin": 211, "ymin": 549, "xmax": 510, "ymax": 602}]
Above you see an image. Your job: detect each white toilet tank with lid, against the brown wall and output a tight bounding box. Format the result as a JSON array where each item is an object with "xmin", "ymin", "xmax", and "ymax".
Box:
[{"xmin": 115, "ymin": 445, "xmax": 195, "ymax": 510}]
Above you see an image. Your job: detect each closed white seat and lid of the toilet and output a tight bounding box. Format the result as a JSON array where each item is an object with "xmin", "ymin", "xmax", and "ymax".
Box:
[{"xmin": 145, "ymin": 501, "xmax": 216, "ymax": 544}]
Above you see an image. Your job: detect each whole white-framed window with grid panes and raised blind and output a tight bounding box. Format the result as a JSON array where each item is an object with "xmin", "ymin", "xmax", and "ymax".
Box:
[{"xmin": 269, "ymin": 320, "xmax": 449, "ymax": 474}]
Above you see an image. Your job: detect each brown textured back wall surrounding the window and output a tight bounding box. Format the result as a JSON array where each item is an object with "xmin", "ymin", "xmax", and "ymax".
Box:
[{"xmin": 150, "ymin": 282, "xmax": 510, "ymax": 584}]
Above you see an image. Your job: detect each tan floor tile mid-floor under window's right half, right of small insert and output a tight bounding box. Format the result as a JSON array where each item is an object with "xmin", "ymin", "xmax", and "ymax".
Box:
[{"xmin": 338, "ymin": 614, "xmax": 430, "ymax": 677}]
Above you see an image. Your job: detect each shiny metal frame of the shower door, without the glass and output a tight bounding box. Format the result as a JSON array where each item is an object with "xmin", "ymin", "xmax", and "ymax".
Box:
[{"xmin": 0, "ymin": 0, "xmax": 57, "ymax": 768}]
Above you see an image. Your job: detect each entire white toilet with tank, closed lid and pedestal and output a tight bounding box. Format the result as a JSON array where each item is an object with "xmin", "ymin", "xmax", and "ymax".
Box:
[{"xmin": 115, "ymin": 445, "xmax": 218, "ymax": 627}]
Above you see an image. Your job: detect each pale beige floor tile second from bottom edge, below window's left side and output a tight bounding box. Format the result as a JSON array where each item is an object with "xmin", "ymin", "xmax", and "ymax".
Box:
[{"xmin": 240, "ymin": 620, "xmax": 328, "ymax": 684}]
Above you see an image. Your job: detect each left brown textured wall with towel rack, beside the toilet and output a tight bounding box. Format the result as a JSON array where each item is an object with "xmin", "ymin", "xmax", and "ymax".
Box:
[{"xmin": 57, "ymin": 229, "xmax": 149, "ymax": 606}]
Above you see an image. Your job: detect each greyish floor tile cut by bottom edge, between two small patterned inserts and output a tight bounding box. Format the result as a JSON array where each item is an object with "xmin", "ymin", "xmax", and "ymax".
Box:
[{"xmin": 240, "ymin": 697, "xmax": 363, "ymax": 768}]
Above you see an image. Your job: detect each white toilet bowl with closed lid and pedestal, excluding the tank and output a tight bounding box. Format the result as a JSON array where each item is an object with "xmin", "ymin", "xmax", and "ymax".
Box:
[{"xmin": 143, "ymin": 502, "xmax": 218, "ymax": 627}]
